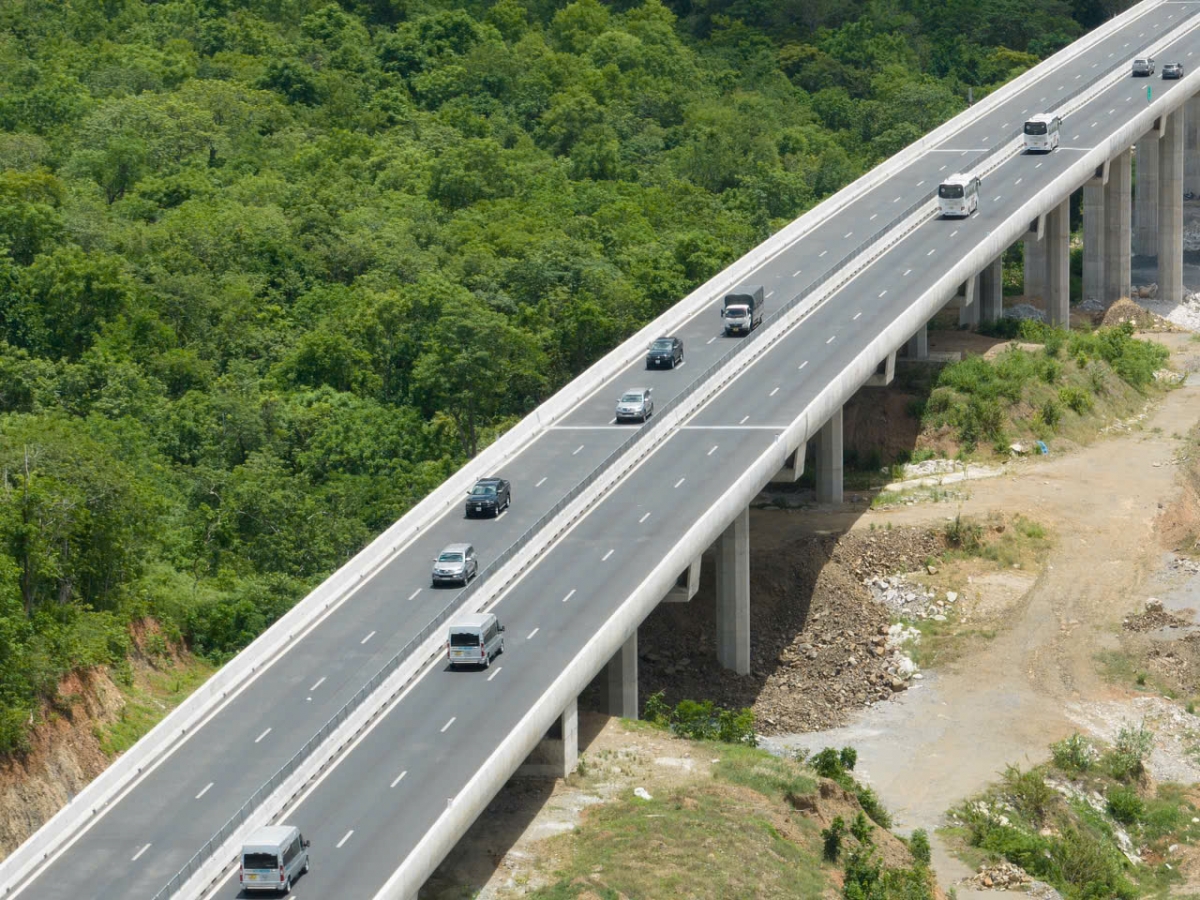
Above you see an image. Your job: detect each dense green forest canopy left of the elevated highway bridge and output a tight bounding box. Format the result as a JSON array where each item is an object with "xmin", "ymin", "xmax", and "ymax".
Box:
[{"xmin": 0, "ymin": 0, "xmax": 1115, "ymax": 751}]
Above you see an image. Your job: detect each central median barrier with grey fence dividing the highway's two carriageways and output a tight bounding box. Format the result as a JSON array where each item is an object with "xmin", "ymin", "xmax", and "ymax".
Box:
[{"xmin": 154, "ymin": 10, "xmax": 1200, "ymax": 900}]
